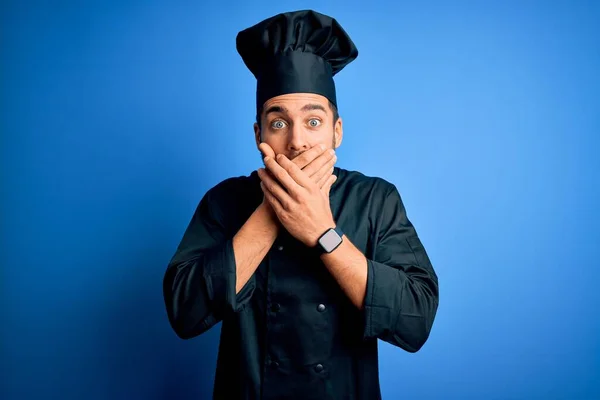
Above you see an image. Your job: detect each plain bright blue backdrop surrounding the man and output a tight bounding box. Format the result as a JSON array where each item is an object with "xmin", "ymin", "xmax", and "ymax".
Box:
[{"xmin": 0, "ymin": 1, "xmax": 600, "ymax": 399}]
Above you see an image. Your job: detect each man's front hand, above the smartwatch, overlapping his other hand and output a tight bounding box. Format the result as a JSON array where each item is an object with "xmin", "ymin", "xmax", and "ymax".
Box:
[{"xmin": 258, "ymin": 154, "xmax": 337, "ymax": 247}]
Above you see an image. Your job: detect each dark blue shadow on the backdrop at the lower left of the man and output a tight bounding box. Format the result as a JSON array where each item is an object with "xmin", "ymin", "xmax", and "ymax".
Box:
[{"xmin": 92, "ymin": 244, "xmax": 220, "ymax": 399}]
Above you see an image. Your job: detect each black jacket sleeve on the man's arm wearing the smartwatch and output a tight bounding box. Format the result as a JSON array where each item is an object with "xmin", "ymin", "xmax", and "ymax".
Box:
[{"xmin": 363, "ymin": 185, "xmax": 439, "ymax": 353}]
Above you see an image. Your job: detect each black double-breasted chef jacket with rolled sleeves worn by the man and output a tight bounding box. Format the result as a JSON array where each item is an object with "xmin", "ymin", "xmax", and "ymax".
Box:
[{"xmin": 164, "ymin": 167, "xmax": 438, "ymax": 400}]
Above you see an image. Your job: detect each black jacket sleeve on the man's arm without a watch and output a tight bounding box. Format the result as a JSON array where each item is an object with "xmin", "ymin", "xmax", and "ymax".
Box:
[{"xmin": 163, "ymin": 191, "xmax": 255, "ymax": 339}]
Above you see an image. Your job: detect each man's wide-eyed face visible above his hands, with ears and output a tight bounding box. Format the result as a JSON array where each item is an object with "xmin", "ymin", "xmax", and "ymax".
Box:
[{"xmin": 254, "ymin": 93, "xmax": 343, "ymax": 160}]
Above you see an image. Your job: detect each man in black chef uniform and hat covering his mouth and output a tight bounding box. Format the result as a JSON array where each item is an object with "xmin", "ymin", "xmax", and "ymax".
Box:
[{"xmin": 164, "ymin": 11, "xmax": 438, "ymax": 400}]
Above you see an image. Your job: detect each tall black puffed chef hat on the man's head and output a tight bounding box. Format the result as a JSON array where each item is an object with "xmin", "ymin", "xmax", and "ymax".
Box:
[{"xmin": 236, "ymin": 10, "xmax": 358, "ymax": 110}]
